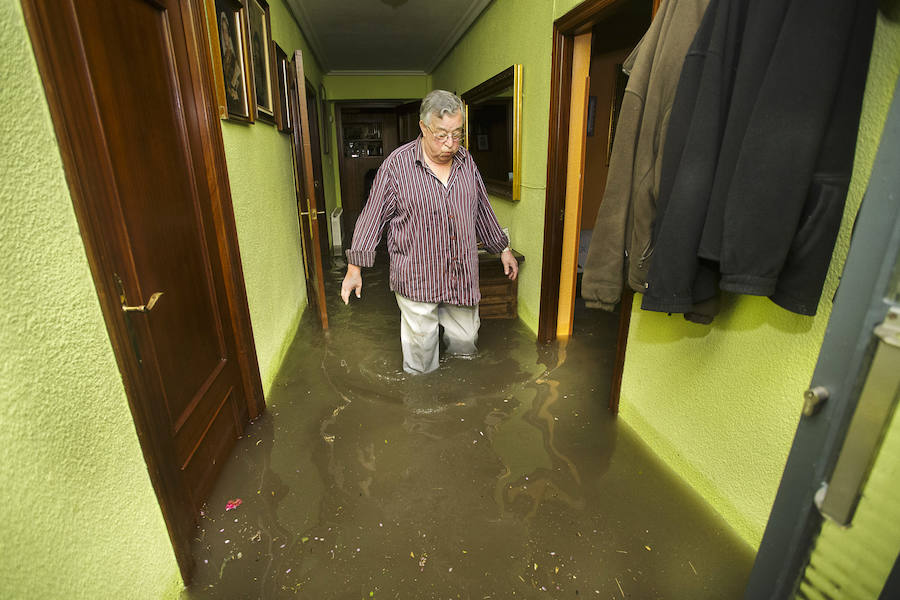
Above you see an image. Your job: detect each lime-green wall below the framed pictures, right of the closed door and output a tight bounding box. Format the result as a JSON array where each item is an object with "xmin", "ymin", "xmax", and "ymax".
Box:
[{"xmin": 222, "ymin": 0, "xmax": 335, "ymax": 394}]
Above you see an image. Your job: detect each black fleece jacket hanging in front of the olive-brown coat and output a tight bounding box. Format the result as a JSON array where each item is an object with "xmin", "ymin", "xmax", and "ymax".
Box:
[{"xmin": 642, "ymin": 0, "xmax": 876, "ymax": 315}]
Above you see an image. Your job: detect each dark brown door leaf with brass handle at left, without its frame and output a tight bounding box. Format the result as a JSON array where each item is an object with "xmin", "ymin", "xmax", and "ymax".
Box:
[{"xmin": 76, "ymin": 0, "xmax": 241, "ymax": 510}]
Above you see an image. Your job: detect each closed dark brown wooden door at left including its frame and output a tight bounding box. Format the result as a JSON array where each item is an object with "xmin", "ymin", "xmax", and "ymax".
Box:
[{"xmin": 23, "ymin": 0, "xmax": 262, "ymax": 581}]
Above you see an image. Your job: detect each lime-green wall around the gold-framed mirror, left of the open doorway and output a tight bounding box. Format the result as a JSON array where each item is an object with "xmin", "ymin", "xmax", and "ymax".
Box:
[{"xmin": 432, "ymin": 0, "xmax": 554, "ymax": 331}]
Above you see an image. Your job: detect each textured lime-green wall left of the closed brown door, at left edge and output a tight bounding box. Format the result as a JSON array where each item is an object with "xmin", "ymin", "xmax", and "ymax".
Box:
[{"xmin": 0, "ymin": 0, "xmax": 179, "ymax": 599}]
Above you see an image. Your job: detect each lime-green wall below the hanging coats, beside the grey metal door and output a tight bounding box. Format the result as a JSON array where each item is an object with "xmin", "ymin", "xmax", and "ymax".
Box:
[{"xmin": 621, "ymin": 14, "xmax": 900, "ymax": 547}]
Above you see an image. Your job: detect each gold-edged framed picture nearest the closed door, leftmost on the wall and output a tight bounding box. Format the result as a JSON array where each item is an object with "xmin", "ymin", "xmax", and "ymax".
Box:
[{"xmin": 208, "ymin": 0, "xmax": 255, "ymax": 123}]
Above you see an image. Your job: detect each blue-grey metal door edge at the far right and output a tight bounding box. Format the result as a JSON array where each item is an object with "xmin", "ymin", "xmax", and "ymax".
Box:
[{"xmin": 744, "ymin": 77, "xmax": 900, "ymax": 600}]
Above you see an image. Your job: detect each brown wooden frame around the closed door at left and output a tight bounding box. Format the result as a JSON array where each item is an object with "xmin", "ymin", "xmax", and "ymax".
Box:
[{"xmin": 22, "ymin": 0, "xmax": 265, "ymax": 583}]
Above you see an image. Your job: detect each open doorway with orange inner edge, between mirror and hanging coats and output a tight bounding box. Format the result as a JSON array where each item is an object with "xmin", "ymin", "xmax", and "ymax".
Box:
[{"xmin": 538, "ymin": 0, "xmax": 657, "ymax": 414}]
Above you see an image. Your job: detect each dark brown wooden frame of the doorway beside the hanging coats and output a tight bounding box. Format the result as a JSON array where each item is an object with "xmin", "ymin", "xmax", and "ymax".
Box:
[{"xmin": 538, "ymin": 0, "xmax": 660, "ymax": 414}]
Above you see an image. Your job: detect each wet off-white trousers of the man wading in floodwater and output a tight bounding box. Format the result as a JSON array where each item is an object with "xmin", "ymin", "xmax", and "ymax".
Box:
[{"xmin": 394, "ymin": 293, "xmax": 481, "ymax": 375}]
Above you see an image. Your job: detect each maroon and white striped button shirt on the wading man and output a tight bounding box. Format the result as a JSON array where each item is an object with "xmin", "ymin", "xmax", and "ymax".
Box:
[{"xmin": 347, "ymin": 136, "xmax": 508, "ymax": 306}]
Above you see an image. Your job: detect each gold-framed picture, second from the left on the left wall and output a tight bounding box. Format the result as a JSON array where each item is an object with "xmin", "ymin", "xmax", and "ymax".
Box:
[{"xmin": 246, "ymin": 0, "xmax": 277, "ymax": 125}]
